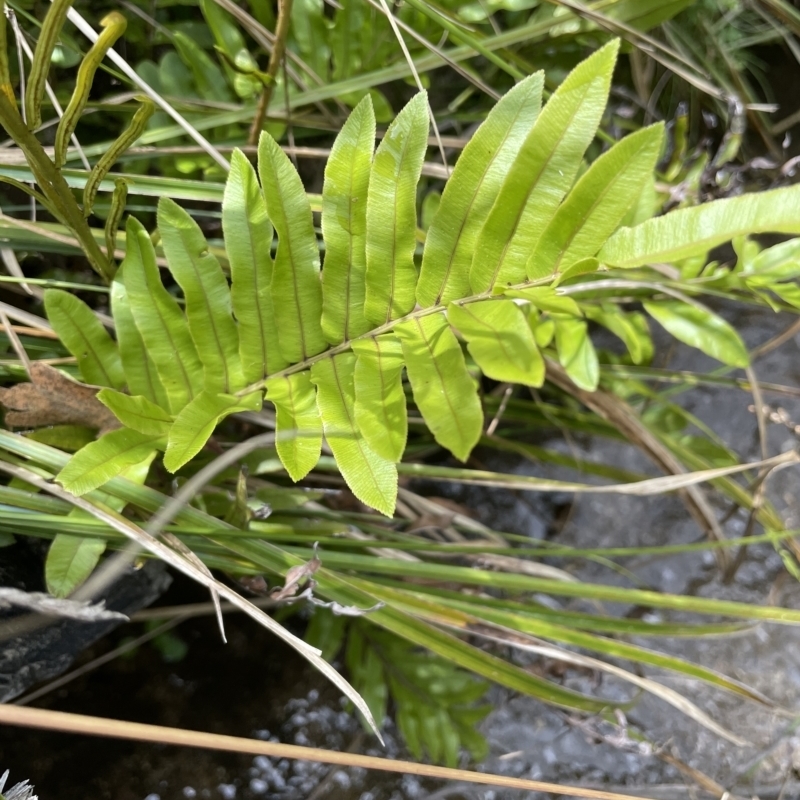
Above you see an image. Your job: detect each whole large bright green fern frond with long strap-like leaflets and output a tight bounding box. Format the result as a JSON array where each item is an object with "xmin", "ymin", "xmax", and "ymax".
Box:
[{"xmin": 47, "ymin": 42, "xmax": 800, "ymax": 516}]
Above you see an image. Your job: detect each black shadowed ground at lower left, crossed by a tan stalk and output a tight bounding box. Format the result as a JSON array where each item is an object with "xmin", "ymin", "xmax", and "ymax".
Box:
[{"xmin": 0, "ymin": 578, "xmax": 350, "ymax": 800}]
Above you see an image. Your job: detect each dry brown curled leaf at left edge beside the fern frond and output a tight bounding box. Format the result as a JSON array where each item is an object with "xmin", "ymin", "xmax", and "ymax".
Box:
[{"xmin": 0, "ymin": 362, "xmax": 121, "ymax": 434}]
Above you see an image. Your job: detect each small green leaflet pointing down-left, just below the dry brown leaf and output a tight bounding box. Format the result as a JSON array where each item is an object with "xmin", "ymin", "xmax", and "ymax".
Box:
[{"xmin": 56, "ymin": 428, "xmax": 164, "ymax": 495}]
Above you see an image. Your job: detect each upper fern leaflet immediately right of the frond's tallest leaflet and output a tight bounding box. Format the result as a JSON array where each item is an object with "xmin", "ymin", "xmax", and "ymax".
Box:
[{"xmin": 527, "ymin": 123, "xmax": 664, "ymax": 279}]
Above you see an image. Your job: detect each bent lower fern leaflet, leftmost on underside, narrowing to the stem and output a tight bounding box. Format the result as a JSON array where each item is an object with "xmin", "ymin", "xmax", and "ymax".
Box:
[{"xmin": 164, "ymin": 391, "xmax": 261, "ymax": 472}]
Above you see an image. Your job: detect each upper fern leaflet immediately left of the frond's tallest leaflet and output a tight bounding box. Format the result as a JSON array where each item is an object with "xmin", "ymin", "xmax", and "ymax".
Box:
[{"xmin": 417, "ymin": 72, "xmax": 544, "ymax": 307}]
